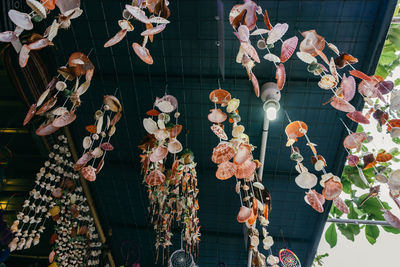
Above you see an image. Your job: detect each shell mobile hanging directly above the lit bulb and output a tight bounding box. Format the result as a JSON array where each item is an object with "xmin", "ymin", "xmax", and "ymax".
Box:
[{"xmin": 229, "ymin": 0, "xmax": 298, "ymax": 97}]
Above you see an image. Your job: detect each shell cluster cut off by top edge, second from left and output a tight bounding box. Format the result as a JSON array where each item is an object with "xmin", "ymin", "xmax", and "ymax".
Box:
[{"xmin": 104, "ymin": 0, "xmax": 170, "ymax": 65}]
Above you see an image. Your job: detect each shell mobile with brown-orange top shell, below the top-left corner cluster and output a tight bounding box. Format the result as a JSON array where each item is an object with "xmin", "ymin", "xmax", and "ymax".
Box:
[{"xmin": 23, "ymin": 52, "xmax": 94, "ymax": 136}]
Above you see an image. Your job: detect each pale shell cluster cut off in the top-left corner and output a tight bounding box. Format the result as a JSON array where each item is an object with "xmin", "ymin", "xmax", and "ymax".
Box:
[{"xmin": 0, "ymin": 0, "xmax": 83, "ymax": 68}]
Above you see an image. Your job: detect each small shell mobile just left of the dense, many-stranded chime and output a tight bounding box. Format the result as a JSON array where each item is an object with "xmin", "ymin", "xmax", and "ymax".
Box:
[{"xmin": 74, "ymin": 95, "xmax": 122, "ymax": 182}]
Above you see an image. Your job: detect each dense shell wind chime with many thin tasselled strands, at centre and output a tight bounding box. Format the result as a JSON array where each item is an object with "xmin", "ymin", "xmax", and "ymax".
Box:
[{"xmin": 139, "ymin": 95, "xmax": 200, "ymax": 261}]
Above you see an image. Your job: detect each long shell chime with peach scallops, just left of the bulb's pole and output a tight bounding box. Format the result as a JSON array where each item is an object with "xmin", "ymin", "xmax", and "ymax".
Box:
[{"xmin": 208, "ymin": 88, "xmax": 279, "ymax": 267}]
